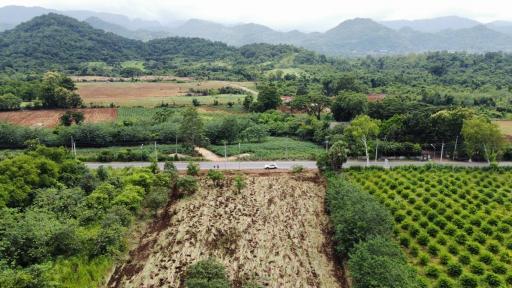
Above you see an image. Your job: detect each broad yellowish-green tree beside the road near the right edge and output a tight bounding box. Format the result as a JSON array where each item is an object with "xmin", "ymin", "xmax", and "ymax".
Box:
[{"xmin": 462, "ymin": 117, "xmax": 505, "ymax": 163}]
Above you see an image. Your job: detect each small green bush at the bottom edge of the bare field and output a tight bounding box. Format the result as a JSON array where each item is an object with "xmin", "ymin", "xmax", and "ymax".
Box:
[{"xmin": 185, "ymin": 259, "xmax": 231, "ymax": 288}]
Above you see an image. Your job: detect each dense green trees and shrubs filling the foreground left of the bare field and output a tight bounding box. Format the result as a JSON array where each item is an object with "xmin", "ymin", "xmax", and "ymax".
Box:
[{"xmin": 0, "ymin": 142, "xmax": 173, "ymax": 287}]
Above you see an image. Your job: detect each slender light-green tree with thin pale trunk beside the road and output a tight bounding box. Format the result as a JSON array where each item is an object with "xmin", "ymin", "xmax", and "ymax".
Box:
[{"xmin": 344, "ymin": 115, "xmax": 380, "ymax": 166}]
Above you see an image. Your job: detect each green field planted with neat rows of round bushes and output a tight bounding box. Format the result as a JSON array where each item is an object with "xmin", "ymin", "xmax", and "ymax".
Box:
[{"xmin": 347, "ymin": 168, "xmax": 512, "ymax": 287}]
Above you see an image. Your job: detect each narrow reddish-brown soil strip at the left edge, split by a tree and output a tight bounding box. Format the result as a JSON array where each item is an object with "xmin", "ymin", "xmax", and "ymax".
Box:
[{"xmin": 0, "ymin": 108, "xmax": 117, "ymax": 128}]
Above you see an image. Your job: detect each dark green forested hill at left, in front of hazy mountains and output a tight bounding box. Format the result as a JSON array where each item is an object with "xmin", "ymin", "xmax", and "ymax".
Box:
[{"xmin": 0, "ymin": 13, "xmax": 325, "ymax": 77}]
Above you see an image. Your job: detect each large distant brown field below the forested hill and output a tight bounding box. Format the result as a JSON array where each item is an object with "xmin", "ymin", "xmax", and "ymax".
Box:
[{"xmin": 77, "ymin": 81, "xmax": 254, "ymax": 107}]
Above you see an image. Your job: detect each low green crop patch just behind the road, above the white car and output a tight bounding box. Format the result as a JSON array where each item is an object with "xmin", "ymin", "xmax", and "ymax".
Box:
[{"xmin": 208, "ymin": 137, "xmax": 323, "ymax": 160}]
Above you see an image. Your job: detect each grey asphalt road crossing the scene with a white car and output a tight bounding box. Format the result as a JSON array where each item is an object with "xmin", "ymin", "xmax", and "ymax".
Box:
[{"xmin": 86, "ymin": 160, "xmax": 512, "ymax": 170}]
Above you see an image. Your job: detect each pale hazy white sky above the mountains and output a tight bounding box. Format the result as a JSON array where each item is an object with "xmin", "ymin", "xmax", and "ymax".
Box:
[{"xmin": 0, "ymin": 0, "xmax": 512, "ymax": 31}]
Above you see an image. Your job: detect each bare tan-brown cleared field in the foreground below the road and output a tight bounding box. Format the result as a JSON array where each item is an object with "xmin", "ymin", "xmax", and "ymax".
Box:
[{"xmin": 108, "ymin": 174, "xmax": 340, "ymax": 288}]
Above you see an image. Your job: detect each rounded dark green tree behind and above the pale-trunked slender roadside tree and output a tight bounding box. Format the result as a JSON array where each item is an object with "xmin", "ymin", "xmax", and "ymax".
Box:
[{"xmin": 331, "ymin": 92, "xmax": 368, "ymax": 121}]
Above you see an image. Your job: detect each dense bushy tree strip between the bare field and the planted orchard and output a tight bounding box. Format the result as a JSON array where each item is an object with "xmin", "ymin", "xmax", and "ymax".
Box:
[{"xmin": 326, "ymin": 176, "xmax": 422, "ymax": 288}]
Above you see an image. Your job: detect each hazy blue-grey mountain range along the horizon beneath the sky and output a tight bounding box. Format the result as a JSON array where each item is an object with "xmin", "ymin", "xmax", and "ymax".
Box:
[{"xmin": 0, "ymin": 6, "xmax": 512, "ymax": 56}]
